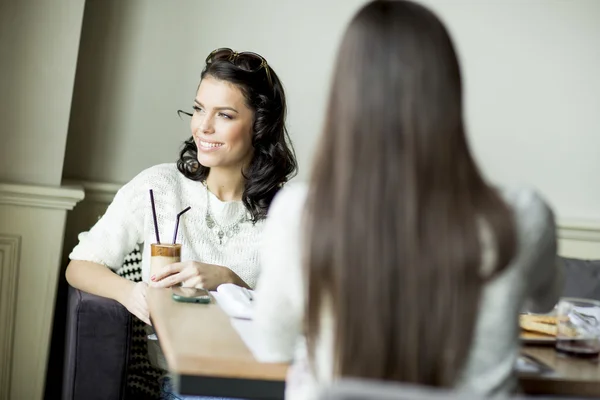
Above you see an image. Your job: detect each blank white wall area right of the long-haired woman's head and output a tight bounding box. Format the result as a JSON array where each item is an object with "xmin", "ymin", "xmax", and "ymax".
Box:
[{"xmin": 423, "ymin": 0, "xmax": 600, "ymax": 221}]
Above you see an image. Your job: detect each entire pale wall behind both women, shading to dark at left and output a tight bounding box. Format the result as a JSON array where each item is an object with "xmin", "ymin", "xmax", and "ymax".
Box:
[{"xmin": 65, "ymin": 0, "xmax": 600, "ymax": 220}]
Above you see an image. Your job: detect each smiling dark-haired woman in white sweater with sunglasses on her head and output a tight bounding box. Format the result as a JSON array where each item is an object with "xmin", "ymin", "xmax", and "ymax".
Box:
[{"xmin": 67, "ymin": 49, "xmax": 296, "ymax": 398}]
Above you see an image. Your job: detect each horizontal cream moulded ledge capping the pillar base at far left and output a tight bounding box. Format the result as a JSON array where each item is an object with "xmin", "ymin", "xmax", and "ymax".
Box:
[{"xmin": 0, "ymin": 182, "xmax": 85, "ymax": 210}]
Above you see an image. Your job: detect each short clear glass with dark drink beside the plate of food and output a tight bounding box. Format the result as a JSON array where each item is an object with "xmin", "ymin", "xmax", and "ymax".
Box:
[{"xmin": 556, "ymin": 297, "xmax": 600, "ymax": 359}]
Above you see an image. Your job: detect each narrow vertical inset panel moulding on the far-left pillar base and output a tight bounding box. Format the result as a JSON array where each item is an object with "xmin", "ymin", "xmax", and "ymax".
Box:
[{"xmin": 0, "ymin": 235, "xmax": 21, "ymax": 399}]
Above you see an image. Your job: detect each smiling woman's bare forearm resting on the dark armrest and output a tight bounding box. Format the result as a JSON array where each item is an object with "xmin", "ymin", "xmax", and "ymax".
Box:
[{"xmin": 65, "ymin": 260, "xmax": 135, "ymax": 304}]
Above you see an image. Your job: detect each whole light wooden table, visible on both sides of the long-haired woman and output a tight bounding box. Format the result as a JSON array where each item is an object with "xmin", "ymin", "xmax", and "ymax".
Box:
[{"xmin": 148, "ymin": 288, "xmax": 600, "ymax": 399}]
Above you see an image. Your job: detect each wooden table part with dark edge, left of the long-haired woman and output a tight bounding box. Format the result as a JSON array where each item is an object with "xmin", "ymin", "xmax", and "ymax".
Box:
[{"xmin": 147, "ymin": 288, "xmax": 287, "ymax": 399}]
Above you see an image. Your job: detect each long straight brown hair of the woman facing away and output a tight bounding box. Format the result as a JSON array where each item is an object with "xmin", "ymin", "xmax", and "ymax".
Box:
[{"xmin": 304, "ymin": 1, "xmax": 516, "ymax": 386}]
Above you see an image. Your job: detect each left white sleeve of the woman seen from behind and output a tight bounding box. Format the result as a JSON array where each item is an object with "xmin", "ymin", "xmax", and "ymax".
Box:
[{"xmin": 254, "ymin": 185, "xmax": 306, "ymax": 362}]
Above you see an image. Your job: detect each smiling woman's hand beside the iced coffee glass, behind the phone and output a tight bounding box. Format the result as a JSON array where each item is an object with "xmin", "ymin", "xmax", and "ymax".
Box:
[{"xmin": 150, "ymin": 261, "xmax": 246, "ymax": 290}]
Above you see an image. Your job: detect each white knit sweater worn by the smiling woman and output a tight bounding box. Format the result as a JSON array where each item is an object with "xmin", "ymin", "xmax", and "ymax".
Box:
[{"xmin": 69, "ymin": 164, "xmax": 264, "ymax": 288}]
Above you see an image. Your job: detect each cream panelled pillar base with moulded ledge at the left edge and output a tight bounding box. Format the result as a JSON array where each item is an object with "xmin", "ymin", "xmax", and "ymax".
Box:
[{"xmin": 0, "ymin": 183, "xmax": 84, "ymax": 400}]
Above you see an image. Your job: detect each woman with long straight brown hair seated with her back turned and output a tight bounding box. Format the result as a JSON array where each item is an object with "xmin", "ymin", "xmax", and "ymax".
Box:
[{"xmin": 255, "ymin": 1, "xmax": 560, "ymax": 398}]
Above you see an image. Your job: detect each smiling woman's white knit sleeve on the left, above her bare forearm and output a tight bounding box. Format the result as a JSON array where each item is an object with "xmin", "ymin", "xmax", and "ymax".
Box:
[{"xmin": 69, "ymin": 170, "xmax": 150, "ymax": 271}]
